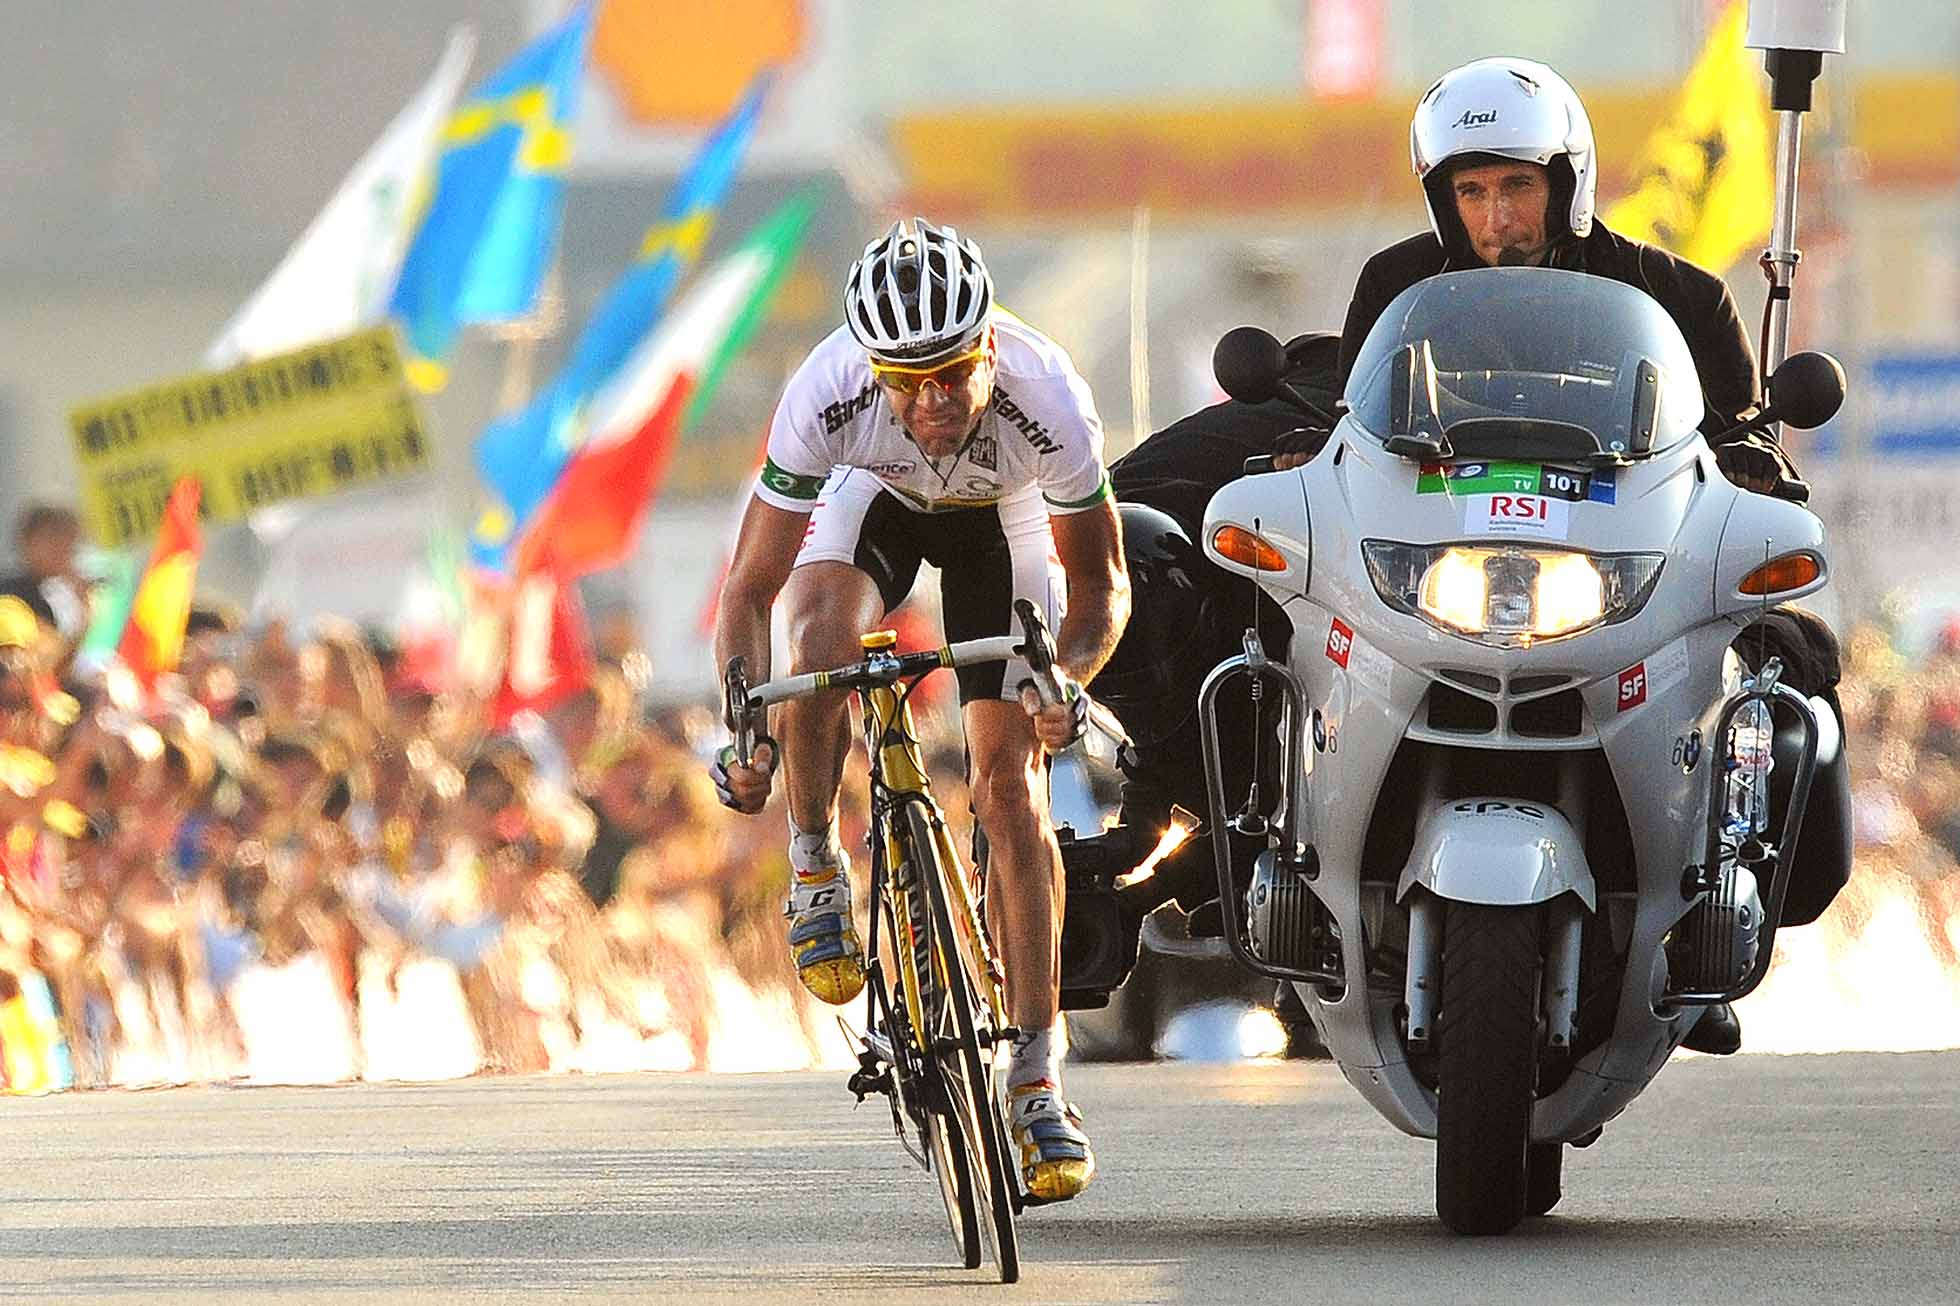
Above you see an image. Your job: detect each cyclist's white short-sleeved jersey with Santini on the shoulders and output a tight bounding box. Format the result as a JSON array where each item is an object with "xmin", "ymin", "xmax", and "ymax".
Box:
[{"xmin": 755, "ymin": 308, "xmax": 1109, "ymax": 514}]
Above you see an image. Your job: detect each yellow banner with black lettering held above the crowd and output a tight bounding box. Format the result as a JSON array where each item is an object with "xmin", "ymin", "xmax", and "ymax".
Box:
[{"xmin": 69, "ymin": 326, "xmax": 429, "ymax": 547}]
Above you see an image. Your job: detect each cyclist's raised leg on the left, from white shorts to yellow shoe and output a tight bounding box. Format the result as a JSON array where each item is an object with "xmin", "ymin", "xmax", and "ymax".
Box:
[{"xmin": 776, "ymin": 469, "xmax": 917, "ymax": 1002}]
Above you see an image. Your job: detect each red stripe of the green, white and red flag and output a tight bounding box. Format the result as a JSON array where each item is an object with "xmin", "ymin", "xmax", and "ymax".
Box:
[{"xmin": 515, "ymin": 375, "xmax": 694, "ymax": 580}]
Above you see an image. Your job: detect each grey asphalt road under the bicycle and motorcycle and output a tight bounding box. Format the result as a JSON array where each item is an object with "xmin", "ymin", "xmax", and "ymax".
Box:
[{"xmin": 0, "ymin": 1053, "xmax": 1960, "ymax": 1306}]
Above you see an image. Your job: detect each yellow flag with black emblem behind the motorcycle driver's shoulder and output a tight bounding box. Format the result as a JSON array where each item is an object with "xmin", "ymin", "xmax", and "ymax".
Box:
[{"xmin": 1605, "ymin": 0, "xmax": 1776, "ymax": 273}]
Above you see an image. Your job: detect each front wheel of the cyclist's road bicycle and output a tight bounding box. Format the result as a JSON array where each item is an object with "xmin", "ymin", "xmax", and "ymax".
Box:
[{"xmin": 904, "ymin": 802, "xmax": 1021, "ymax": 1282}]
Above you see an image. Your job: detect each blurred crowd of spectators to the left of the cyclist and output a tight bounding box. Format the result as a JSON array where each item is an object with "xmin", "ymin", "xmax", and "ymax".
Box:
[{"xmin": 0, "ymin": 508, "xmax": 956, "ymax": 1086}]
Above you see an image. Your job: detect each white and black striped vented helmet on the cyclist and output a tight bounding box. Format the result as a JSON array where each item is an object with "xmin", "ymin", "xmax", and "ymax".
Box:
[{"xmin": 845, "ymin": 218, "xmax": 994, "ymax": 363}]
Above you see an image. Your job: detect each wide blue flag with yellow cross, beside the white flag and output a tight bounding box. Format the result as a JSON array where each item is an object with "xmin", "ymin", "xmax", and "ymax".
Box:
[{"xmin": 390, "ymin": 0, "xmax": 594, "ymax": 390}]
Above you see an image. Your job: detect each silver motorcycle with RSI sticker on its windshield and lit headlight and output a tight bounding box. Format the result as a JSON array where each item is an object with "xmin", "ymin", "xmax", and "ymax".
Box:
[{"xmin": 1198, "ymin": 267, "xmax": 1844, "ymax": 1233}]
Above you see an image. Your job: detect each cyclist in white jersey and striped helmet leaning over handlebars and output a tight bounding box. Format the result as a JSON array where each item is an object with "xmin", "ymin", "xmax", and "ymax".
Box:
[{"xmin": 713, "ymin": 218, "xmax": 1129, "ymax": 1200}]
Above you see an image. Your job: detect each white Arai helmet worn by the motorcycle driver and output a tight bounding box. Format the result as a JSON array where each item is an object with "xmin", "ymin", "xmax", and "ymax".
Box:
[{"xmin": 1409, "ymin": 59, "xmax": 1599, "ymax": 247}]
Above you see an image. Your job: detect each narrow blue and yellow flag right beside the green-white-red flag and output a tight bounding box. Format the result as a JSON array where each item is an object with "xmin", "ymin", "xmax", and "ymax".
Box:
[{"xmin": 476, "ymin": 73, "xmax": 770, "ymax": 555}]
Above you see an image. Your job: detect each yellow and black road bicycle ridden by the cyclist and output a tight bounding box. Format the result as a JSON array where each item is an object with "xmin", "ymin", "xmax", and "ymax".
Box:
[{"xmin": 723, "ymin": 600, "xmax": 1060, "ymax": 1282}]
